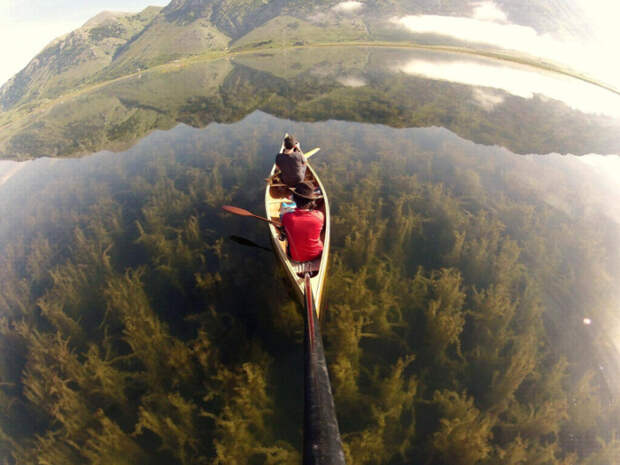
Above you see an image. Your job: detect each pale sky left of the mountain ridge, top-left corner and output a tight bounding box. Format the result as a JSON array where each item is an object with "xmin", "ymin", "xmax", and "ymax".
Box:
[{"xmin": 0, "ymin": 0, "xmax": 169, "ymax": 86}]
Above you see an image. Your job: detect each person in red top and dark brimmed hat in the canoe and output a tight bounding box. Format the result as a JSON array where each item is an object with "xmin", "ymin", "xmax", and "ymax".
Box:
[{"xmin": 282, "ymin": 181, "xmax": 325, "ymax": 262}]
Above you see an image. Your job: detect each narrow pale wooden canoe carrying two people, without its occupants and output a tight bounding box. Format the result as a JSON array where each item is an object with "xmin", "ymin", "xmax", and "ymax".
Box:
[{"xmin": 265, "ymin": 140, "xmax": 330, "ymax": 318}]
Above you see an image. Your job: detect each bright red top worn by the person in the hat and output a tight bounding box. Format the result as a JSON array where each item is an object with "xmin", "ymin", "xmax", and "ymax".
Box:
[{"xmin": 282, "ymin": 209, "xmax": 324, "ymax": 262}]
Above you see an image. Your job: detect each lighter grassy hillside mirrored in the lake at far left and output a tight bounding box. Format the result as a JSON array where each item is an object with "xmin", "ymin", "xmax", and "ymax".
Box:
[{"xmin": 0, "ymin": 60, "xmax": 232, "ymax": 159}]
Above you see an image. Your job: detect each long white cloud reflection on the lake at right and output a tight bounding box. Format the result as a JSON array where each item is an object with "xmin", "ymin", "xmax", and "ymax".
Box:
[{"xmin": 395, "ymin": 59, "xmax": 620, "ymax": 118}]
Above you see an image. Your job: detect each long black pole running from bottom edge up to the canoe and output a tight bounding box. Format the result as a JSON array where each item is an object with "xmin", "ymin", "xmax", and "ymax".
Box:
[{"xmin": 303, "ymin": 274, "xmax": 345, "ymax": 465}]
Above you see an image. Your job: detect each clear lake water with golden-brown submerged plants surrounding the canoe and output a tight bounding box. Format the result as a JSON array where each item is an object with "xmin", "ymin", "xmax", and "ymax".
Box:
[{"xmin": 0, "ymin": 113, "xmax": 620, "ymax": 465}]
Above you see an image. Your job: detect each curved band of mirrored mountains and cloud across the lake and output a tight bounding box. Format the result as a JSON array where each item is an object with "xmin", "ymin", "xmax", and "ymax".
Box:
[{"xmin": 0, "ymin": 47, "xmax": 620, "ymax": 158}]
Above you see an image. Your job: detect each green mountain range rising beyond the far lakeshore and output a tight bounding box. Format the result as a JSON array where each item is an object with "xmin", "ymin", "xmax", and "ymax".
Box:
[{"xmin": 0, "ymin": 0, "xmax": 583, "ymax": 112}]
